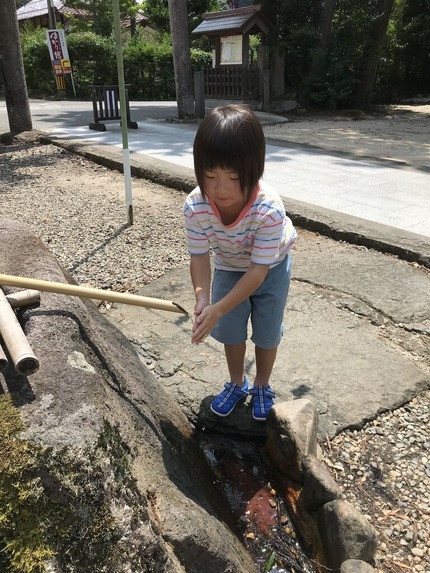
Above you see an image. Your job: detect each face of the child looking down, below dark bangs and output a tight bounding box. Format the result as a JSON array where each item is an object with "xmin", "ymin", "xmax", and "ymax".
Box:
[{"xmin": 204, "ymin": 167, "xmax": 244, "ymax": 209}]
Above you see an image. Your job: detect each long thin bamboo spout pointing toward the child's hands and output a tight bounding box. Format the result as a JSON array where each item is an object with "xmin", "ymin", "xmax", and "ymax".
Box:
[{"xmin": 0, "ymin": 274, "xmax": 188, "ymax": 316}]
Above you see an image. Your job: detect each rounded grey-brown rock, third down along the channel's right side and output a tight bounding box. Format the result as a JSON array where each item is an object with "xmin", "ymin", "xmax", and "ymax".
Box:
[{"xmin": 318, "ymin": 500, "xmax": 377, "ymax": 569}]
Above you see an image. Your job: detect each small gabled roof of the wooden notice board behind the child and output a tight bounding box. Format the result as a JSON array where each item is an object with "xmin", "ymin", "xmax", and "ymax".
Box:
[{"xmin": 192, "ymin": 5, "xmax": 271, "ymax": 36}]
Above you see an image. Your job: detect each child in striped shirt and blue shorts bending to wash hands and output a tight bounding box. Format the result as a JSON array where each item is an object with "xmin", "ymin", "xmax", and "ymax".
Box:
[{"xmin": 184, "ymin": 105, "xmax": 297, "ymax": 422}]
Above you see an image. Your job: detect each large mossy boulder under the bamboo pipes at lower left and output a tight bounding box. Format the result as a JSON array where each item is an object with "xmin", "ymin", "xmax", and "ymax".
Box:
[{"xmin": 0, "ymin": 220, "xmax": 256, "ymax": 573}]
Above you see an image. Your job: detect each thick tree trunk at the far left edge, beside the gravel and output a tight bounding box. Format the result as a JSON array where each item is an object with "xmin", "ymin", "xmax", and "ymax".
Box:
[{"xmin": 0, "ymin": 0, "xmax": 33, "ymax": 134}]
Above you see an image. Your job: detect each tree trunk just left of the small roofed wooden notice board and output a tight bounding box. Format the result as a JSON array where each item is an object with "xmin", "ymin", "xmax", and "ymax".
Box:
[{"xmin": 168, "ymin": 0, "xmax": 194, "ymax": 119}]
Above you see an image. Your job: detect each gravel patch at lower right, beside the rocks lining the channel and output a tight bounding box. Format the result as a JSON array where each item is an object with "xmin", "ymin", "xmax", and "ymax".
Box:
[{"xmin": 324, "ymin": 391, "xmax": 430, "ymax": 573}]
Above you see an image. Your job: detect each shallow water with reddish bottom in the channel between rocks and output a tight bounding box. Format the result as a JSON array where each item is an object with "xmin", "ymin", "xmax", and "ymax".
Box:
[{"xmin": 199, "ymin": 432, "xmax": 318, "ymax": 573}]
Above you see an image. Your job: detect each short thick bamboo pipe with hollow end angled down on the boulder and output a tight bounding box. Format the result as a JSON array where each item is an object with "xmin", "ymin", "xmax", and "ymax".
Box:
[{"xmin": 0, "ymin": 289, "xmax": 39, "ymax": 376}]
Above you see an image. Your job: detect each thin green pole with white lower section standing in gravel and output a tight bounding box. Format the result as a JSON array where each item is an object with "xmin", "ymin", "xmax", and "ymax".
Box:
[{"xmin": 112, "ymin": 0, "xmax": 133, "ymax": 225}]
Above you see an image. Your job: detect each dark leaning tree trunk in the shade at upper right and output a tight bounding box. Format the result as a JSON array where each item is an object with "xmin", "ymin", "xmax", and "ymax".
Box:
[{"xmin": 355, "ymin": 0, "xmax": 394, "ymax": 108}]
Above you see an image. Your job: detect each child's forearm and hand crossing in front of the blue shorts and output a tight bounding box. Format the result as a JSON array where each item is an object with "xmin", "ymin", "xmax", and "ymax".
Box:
[{"xmin": 191, "ymin": 263, "xmax": 270, "ymax": 344}]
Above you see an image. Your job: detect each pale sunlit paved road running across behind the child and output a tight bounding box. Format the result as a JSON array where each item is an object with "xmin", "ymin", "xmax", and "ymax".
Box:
[{"xmin": 0, "ymin": 100, "xmax": 430, "ymax": 241}]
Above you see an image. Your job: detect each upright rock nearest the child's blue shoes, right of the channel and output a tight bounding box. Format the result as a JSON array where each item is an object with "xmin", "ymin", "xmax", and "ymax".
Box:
[{"xmin": 266, "ymin": 398, "xmax": 318, "ymax": 483}]
